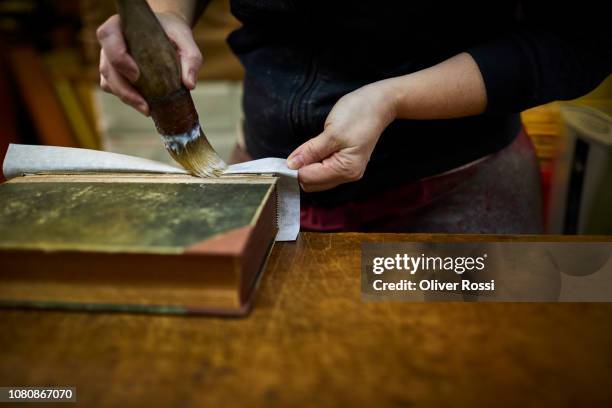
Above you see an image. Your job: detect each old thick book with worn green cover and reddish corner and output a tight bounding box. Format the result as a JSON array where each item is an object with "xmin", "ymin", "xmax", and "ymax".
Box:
[{"xmin": 0, "ymin": 174, "xmax": 278, "ymax": 314}]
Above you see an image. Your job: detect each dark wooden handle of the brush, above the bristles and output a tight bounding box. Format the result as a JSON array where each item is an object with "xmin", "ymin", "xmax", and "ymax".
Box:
[{"xmin": 116, "ymin": 0, "xmax": 198, "ymax": 136}]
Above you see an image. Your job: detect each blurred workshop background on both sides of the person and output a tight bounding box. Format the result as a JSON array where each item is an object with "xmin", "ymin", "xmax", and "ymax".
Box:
[{"xmin": 0, "ymin": 0, "xmax": 612, "ymax": 234}]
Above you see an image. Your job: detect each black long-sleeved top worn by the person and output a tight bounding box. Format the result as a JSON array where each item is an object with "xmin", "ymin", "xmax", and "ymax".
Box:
[{"xmin": 228, "ymin": 0, "xmax": 612, "ymax": 204}]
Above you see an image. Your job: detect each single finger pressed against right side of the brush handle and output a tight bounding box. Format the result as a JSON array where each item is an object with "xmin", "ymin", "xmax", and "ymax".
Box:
[{"xmin": 164, "ymin": 24, "xmax": 203, "ymax": 89}]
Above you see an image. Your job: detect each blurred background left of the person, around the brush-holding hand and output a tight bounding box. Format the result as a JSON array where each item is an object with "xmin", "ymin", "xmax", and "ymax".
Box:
[{"xmin": 0, "ymin": 0, "xmax": 243, "ymax": 162}]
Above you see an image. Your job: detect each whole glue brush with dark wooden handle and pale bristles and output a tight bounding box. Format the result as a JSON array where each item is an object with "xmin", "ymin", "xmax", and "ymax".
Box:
[{"xmin": 116, "ymin": 0, "xmax": 227, "ymax": 177}]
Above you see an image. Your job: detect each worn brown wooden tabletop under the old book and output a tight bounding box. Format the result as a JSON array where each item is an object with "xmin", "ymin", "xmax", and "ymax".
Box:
[{"xmin": 0, "ymin": 233, "xmax": 612, "ymax": 406}]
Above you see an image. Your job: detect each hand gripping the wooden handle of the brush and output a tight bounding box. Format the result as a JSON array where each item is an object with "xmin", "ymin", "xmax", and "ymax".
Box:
[{"xmin": 96, "ymin": 12, "xmax": 202, "ymax": 116}]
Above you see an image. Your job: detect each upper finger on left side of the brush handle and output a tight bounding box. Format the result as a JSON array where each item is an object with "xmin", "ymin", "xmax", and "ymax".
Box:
[{"xmin": 96, "ymin": 15, "xmax": 140, "ymax": 82}]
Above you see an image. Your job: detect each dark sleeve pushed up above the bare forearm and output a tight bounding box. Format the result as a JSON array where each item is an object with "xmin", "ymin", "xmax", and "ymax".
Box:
[{"xmin": 467, "ymin": 0, "xmax": 612, "ymax": 112}]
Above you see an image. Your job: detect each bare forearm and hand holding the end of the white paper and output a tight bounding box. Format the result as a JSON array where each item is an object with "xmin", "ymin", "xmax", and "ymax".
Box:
[{"xmin": 287, "ymin": 52, "xmax": 487, "ymax": 191}]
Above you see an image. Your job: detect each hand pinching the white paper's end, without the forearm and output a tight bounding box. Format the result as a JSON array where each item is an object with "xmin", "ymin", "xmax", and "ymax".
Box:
[{"xmin": 287, "ymin": 81, "xmax": 396, "ymax": 192}]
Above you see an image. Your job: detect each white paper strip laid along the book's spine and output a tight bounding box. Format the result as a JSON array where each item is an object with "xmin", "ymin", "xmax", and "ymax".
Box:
[{"xmin": 2, "ymin": 144, "xmax": 300, "ymax": 241}]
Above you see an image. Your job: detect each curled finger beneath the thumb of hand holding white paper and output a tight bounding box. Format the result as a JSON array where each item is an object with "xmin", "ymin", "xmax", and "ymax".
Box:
[{"xmin": 298, "ymin": 153, "xmax": 365, "ymax": 192}]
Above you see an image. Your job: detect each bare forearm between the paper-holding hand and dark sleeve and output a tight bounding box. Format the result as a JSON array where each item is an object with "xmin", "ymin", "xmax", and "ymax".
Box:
[{"xmin": 382, "ymin": 53, "xmax": 487, "ymax": 119}]
